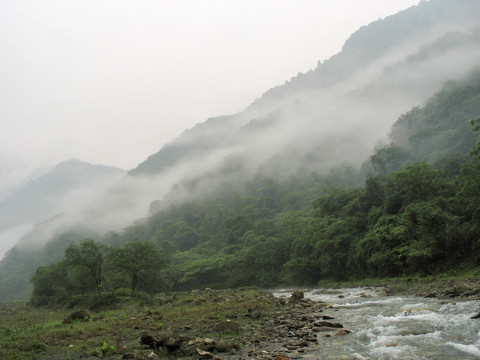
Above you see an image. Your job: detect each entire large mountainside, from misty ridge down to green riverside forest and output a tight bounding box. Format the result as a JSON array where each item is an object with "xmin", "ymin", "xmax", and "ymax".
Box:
[{"xmin": 0, "ymin": 0, "xmax": 480, "ymax": 299}]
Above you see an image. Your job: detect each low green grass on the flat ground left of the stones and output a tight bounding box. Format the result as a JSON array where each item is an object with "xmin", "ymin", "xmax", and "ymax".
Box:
[{"xmin": 0, "ymin": 288, "xmax": 282, "ymax": 360}]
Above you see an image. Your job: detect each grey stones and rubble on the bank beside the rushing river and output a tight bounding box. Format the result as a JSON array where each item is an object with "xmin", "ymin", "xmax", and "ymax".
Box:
[{"xmin": 135, "ymin": 291, "xmax": 350, "ymax": 360}]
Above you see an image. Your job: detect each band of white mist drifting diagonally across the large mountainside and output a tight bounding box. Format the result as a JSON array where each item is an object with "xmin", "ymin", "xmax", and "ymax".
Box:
[{"xmin": 24, "ymin": 21, "xmax": 480, "ymax": 250}]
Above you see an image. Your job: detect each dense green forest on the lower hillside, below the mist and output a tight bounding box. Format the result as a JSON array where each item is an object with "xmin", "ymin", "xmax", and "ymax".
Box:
[{"xmin": 20, "ymin": 82, "xmax": 480, "ymax": 300}]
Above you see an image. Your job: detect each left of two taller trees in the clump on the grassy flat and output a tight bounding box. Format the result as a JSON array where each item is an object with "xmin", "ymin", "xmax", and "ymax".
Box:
[{"xmin": 65, "ymin": 239, "xmax": 104, "ymax": 291}]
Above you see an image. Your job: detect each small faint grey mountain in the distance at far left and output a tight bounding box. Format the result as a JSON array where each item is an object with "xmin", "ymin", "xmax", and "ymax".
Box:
[{"xmin": 0, "ymin": 159, "xmax": 126, "ymax": 254}]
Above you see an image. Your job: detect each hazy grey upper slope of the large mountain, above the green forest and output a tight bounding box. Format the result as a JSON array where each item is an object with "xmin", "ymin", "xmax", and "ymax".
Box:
[{"xmin": 130, "ymin": 0, "xmax": 480, "ymax": 186}]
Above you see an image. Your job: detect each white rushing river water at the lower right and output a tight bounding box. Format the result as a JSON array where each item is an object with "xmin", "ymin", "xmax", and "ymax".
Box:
[{"xmin": 276, "ymin": 288, "xmax": 480, "ymax": 360}]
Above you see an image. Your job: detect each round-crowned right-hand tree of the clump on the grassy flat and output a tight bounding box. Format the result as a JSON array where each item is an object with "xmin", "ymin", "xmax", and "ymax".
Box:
[{"xmin": 109, "ymin": 241, "xmax": 164, "ymax": 292}]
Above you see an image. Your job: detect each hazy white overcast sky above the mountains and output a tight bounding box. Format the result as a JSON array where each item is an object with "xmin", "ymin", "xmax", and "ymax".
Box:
[{"xmin": 0, "ymin": 0, "xmax": 419, "ymax": 192}]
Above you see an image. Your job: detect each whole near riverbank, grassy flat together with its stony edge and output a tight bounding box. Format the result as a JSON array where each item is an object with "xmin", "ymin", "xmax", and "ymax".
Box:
[{"xmin": 0, "ymin": 288, "xmax": 349, "ymax": 360}]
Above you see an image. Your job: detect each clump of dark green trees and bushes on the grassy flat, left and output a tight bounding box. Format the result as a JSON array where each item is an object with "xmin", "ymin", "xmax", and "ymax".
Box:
[{"xmin": 30, "ymin": 239, "xmax": 164, "ymax": 309}]
